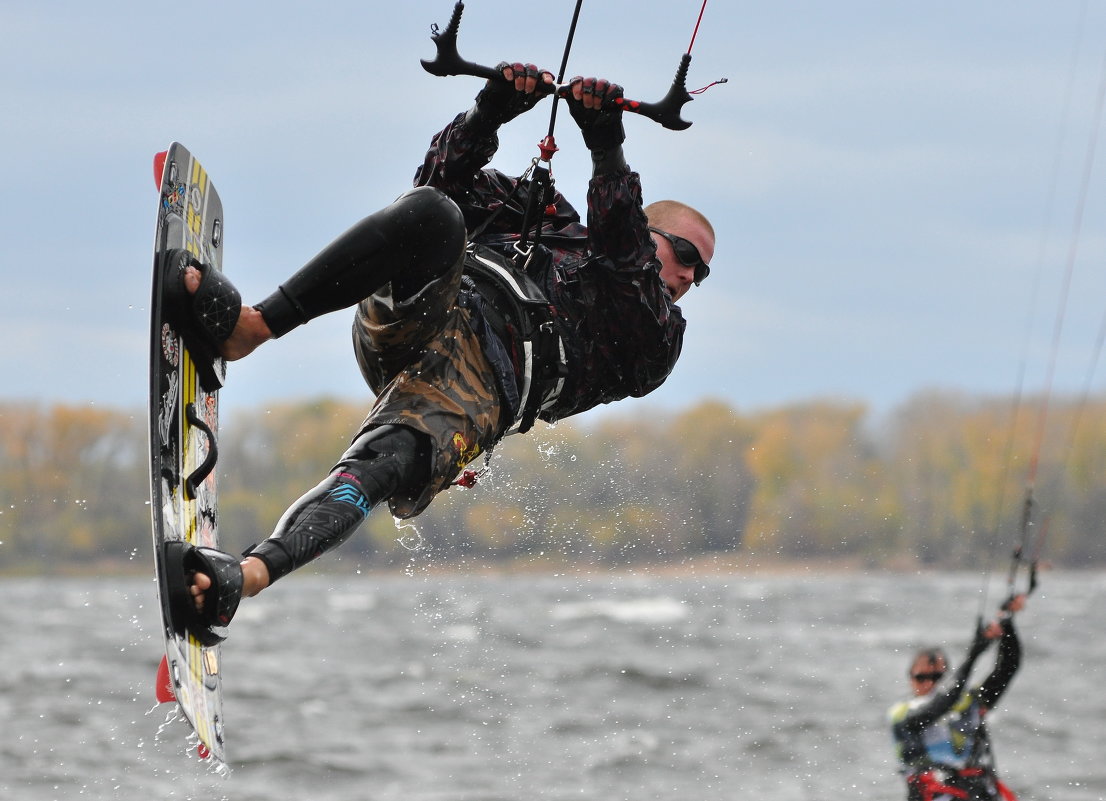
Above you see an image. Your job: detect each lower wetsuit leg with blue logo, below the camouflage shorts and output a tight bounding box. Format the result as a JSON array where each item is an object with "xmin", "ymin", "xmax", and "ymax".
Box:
[{"xmin": 248, "ymin": 425, "xmax": 430, "ymax": 583}]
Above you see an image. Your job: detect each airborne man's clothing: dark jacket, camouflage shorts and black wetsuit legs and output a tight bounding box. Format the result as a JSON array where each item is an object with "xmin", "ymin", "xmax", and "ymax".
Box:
[{"xmin": 246, "ymin": 106, "xmax": 685, "ymax": 581}]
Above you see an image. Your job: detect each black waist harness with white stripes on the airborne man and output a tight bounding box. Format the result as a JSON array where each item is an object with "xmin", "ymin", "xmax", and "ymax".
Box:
[{"xmin": 462, "ymin": 243, "xmax": 568, "ymax": 434}]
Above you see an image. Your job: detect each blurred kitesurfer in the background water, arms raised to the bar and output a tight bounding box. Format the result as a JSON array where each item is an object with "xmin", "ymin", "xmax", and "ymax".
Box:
[{"xmin": 888, "ymin": 595, "xmax": 1025, "ymax": 801}]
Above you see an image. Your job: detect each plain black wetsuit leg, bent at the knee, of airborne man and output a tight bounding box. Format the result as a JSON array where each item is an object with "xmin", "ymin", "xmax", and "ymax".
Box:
[{"xmin": 257, "ymin": 187, "xmax": 466, "ymax": 336}]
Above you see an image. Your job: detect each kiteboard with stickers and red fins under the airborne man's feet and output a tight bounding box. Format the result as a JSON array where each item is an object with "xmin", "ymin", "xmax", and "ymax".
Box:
[{"xmin": 149, "ymin": 143, "xmax": 226, "ymax": 764}]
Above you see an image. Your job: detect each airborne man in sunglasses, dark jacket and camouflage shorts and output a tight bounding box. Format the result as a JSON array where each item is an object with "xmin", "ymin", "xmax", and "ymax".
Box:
[{"xmin": 165, "ymin": 63, "xmax": 714, "ymax": 642}]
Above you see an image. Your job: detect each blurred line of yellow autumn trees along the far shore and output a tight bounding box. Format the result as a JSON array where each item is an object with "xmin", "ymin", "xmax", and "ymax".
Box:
[{"xmin": 0, "ymin": 393, "xmax": 1106, "ymax": 573}]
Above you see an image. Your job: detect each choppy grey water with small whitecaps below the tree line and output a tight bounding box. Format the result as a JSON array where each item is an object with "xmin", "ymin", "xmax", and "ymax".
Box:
[{"xmin": 0, "ymin": 573, "xmax": 1106, "ymax": 801}]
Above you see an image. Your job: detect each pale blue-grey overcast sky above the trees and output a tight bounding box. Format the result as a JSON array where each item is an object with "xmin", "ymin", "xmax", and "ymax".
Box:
[{"xmin": 0, "ymin": 0, "xmax": 1106, "ymax": 424}]
